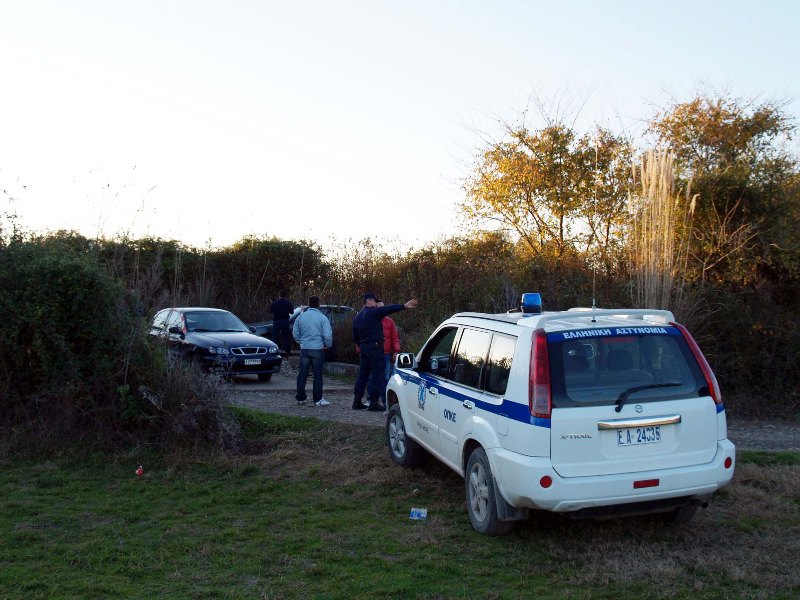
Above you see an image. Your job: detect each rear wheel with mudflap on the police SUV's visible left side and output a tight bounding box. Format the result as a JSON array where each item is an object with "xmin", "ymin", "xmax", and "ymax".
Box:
[{"xmin": 464, "ymin": 446, "xmax": 514, "ymax": 535}]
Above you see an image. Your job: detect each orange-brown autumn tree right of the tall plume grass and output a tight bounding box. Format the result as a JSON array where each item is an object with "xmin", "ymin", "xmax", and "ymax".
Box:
[{"xmin": 650, "ymin": 95, "xmax": 800, "ymax": 284}]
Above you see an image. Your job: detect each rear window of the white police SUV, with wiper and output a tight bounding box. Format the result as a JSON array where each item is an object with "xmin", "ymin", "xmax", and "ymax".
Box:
[{"xmin": 547, "ymin": 326, "xmax": 708, "ymax": 407}]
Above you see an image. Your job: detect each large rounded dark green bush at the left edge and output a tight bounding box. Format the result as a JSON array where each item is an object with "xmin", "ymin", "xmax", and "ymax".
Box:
[{"xmin": 0, "ymin": 241, "xmax": 155, "ymax": 450}]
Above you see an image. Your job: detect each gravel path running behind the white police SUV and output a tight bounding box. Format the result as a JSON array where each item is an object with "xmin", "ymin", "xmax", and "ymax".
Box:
[{"xmin": 229, "ymin": 366, "xmax": 800, "ymax": 451}]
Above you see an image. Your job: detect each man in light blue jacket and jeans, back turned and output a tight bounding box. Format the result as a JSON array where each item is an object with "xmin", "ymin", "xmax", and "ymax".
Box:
[{"xmin": 292, "ymin": 296, "xmax": 333, "ymax": 406}]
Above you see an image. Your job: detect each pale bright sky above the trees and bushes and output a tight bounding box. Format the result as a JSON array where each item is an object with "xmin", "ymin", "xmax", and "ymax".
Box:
[{"xmin": 0, "ymin": 0, "xmax": 800, "ymax": 246}]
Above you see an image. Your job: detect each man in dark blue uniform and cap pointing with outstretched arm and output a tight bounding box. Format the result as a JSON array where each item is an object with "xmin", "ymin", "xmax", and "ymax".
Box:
[{"xmin": 353, "ymin": 292, "xmax": 417, "ymax": 412}]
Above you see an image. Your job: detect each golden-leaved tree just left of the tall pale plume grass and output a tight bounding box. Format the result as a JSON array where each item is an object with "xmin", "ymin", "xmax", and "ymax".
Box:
[{"xmin": 461, "ymin": 121, "xmax": 633, "ymax": 268}]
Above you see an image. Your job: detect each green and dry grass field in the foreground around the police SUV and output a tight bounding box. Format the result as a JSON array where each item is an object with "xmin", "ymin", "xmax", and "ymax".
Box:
[{"xmin": 0, "ymin": 410, "xmax": 800, "ymax": 599}]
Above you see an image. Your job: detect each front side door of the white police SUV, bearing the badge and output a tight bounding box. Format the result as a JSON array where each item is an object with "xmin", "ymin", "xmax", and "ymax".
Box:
[{"xmin": 404, "ymin": 326, "xmax": 458, "ymax": 452}]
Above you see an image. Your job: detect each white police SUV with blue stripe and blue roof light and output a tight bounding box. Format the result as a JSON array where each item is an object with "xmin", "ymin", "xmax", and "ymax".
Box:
[{"xmin": 386, "ymin": 294, "xmax": 735, "ymax": 535}]
